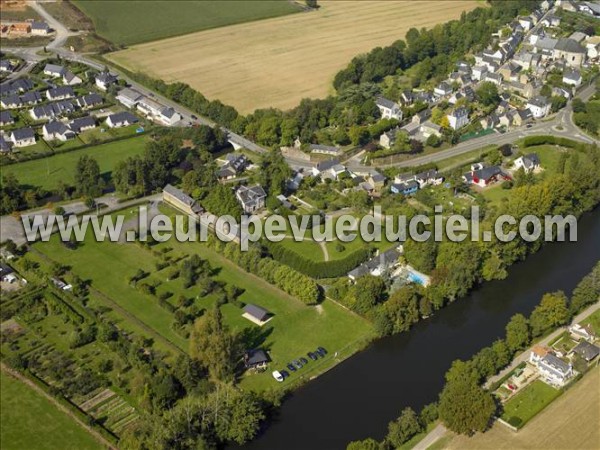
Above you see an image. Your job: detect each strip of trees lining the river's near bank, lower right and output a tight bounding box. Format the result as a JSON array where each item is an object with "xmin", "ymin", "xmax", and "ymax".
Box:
[{"xmin": 348, "ymin": 263, "xmax": 600, "ymax": 450}]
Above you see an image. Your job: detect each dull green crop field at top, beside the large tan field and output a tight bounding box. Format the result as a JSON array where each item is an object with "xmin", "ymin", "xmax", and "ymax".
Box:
[{"xmin": 74, "ymin": 0, "xmax": 300, "ymax": 45}]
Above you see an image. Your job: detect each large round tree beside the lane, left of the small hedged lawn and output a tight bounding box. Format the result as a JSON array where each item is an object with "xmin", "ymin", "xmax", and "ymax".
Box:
[{"xmin": 438, "ymin": 369, "xmax": 496, "ymax": 435}]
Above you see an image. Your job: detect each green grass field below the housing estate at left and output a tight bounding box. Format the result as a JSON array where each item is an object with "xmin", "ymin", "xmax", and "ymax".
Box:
[{"xmin": 1, "ymin": 136, "xmax": 146, "ymax": 189}]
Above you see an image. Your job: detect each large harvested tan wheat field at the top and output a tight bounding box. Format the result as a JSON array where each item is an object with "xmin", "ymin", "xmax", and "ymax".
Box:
[{"xmin": 108, "ymin": 0, "xmax": 481, "ymax": 113}]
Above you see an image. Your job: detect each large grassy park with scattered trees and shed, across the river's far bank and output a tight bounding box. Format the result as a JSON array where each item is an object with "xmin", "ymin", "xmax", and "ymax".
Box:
[{"xmin": 32, "ymin": 208, "xmax": 374, "ymax": 390}]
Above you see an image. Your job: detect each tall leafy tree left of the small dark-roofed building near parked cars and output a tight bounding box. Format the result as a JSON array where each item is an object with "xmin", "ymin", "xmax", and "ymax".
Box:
[{"xmin": 190, "ymin": 307, "xmax": 238, "ymax": 381}]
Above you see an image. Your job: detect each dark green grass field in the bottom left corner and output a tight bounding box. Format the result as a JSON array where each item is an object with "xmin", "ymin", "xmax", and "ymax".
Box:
[{"xmin": 0, "ymin": 372, "xmax": 104, "ymax": 450}]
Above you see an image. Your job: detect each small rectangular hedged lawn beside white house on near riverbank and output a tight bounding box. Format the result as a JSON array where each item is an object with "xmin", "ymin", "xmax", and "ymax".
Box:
[{"xmin": 502, "ymin": 380, "xmax": 561, "ymax": 428}]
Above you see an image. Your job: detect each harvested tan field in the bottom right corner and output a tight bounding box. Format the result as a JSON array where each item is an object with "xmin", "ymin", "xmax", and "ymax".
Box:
[{"xmin": 444, "ymin": 368, "xmax": 600, "ymax": 450}]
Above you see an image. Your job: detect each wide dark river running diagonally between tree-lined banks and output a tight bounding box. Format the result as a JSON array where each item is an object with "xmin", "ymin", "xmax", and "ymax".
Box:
[{"xmin": 244, "ymin": 208, "xmax": 600, "ymax": 450}]
